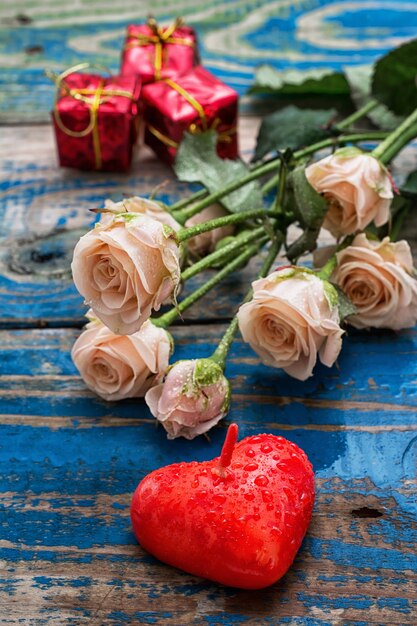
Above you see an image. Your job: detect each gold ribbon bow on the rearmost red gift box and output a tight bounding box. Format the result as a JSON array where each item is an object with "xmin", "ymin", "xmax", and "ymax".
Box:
[{"xmin": 124, "ymin": 17, "xmax": 195, "ymax": 80}]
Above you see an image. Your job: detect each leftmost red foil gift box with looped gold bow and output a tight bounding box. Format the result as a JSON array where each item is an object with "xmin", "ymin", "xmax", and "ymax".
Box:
[{"xmin": 52, "ymin": 72, "xmax": 140, "ymax": 171}]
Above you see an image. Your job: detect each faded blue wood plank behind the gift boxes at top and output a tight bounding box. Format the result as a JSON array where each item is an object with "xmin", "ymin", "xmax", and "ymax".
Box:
[{"xmin": 0, "ymin": 0, "xmax": 416, "ymax": 122}]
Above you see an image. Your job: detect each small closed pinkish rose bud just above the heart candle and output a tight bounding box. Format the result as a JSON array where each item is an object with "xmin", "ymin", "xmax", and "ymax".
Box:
[{"xmin": 145, "ymin": 359, "xmax": 230, "ymax": 439}]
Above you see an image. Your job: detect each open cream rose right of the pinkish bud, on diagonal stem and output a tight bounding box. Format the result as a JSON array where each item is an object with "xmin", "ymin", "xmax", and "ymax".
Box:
[{"xmin": 238, "ymin": 268, "xmax": 343, "ymax": 380}]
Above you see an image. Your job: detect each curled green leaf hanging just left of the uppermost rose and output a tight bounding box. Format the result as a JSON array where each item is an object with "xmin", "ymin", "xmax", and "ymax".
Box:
[{"xmin": 287, "ymin": 167, "xmax": 328, "ymax": 262}]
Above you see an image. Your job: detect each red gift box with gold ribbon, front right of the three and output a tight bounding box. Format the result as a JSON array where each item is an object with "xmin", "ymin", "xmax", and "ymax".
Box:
[{"xmin": 141, "ymin": 66, "xmax": 238, "ymax": 164}]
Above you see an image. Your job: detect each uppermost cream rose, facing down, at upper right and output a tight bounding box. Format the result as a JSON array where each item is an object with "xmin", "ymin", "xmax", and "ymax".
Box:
[{"xmin": 305, "ymin": 148, "xmax": 393, "ymax": 238}]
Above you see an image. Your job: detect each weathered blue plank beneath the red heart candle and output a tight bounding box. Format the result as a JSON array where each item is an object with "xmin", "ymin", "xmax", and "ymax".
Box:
[{"xmin": 0, "ymin": 325, "xmax": 417, "ymax": 626}]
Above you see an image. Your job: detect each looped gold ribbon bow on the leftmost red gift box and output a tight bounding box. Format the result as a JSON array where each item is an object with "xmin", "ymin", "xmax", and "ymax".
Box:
[{"xmin": 45, "ymin": 63, "xmax": 136, "ymax": 170}]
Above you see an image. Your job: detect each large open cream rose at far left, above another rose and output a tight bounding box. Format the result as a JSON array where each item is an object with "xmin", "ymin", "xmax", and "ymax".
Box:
[{"xmin": 72, "ymin": 213, "xmax": 180, "ymax": 335}]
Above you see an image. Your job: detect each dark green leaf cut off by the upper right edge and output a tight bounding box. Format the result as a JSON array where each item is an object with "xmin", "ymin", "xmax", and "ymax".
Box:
[{"xmin": 372, "ymin": 39, "xmax": 417, "ymax": 115}]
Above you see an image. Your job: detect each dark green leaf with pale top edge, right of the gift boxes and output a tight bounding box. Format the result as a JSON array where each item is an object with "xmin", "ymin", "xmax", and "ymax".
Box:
[{"xmin": 249, "ymin": 65, "xmax": 349, "ymax": 96}]
